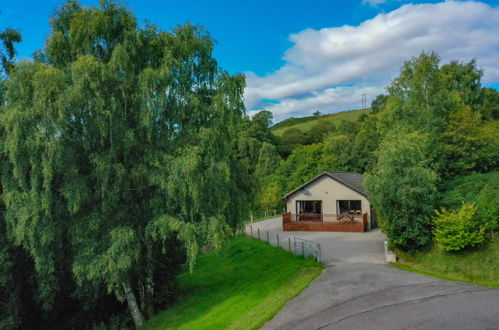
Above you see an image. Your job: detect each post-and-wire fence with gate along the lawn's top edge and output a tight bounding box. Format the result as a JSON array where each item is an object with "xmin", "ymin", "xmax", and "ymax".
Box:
[{"xmin": 245, "ymin": 225, "xmax": 321, "ymax": 262}]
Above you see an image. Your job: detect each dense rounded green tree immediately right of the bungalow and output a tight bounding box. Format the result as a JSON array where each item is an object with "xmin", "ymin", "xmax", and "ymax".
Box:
[{"xmin": 365, "ymin": 130, "xmax": 437, "ymax": 251}]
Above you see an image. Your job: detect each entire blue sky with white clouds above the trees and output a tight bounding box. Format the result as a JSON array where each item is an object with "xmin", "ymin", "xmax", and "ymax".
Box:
[{"xmin": 0, "ymin": 0, "xmax": 499, "ymax": 122}]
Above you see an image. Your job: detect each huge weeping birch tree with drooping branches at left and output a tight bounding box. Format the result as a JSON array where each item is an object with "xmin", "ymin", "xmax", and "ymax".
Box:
[{"xmin": 2, "ymin": 1, "xmax": 251, "ymax": 327}]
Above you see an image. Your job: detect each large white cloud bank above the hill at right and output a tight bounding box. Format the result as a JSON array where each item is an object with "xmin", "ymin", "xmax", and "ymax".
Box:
[{"xmin": 245, "ymin": 1, "xmax": 499, "ymax": 120}]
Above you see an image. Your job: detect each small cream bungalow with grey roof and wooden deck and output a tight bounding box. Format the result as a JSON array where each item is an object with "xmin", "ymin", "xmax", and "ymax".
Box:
[{"xmin": 283, "ymin": 172, "xmax": 376, "ymax": 232}]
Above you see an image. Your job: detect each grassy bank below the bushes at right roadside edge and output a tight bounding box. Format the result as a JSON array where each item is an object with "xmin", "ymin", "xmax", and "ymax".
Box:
[{"xmin": 392, "ymin": 234, "xmax": 499, "ymax": 287}]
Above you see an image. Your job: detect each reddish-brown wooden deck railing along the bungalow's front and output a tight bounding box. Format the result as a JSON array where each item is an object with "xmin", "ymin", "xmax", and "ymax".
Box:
[{"xmin": 282, "ymin": 213, "xmax": 367, "ymax": 233}]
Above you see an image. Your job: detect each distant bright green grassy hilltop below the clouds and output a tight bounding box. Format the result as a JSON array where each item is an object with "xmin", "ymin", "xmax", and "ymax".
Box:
[{"xmin": 271, "ymin": 109, "xmax": 369, "ymax": 136}]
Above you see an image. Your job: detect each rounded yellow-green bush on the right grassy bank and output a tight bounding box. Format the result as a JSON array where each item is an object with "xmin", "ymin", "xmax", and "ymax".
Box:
[{"xmin": 433, "ymin": 203, "xmax": 486, "ymax": 251}]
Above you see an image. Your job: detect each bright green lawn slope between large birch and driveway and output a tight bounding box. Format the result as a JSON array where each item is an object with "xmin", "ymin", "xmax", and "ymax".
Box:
[{"xmin": 144, "ymin": 236, "xmax": 323, "ymax": 329}]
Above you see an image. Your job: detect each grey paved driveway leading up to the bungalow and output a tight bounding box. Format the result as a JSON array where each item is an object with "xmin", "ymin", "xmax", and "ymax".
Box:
[{"xmin": 247, "ymin": 218, "xmax": 499, "ymax": 329}]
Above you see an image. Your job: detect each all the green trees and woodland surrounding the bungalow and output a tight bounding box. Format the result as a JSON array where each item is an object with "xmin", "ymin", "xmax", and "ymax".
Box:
[{"xmin": 0, "ymin": 1, "xmax": 499, "ymax": 329}]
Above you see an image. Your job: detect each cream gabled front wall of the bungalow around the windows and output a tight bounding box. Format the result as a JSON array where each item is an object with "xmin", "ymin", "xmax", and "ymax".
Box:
[{"xmin": 287, "ymin": 175, "xmax": 371, "ymax": 221}]
